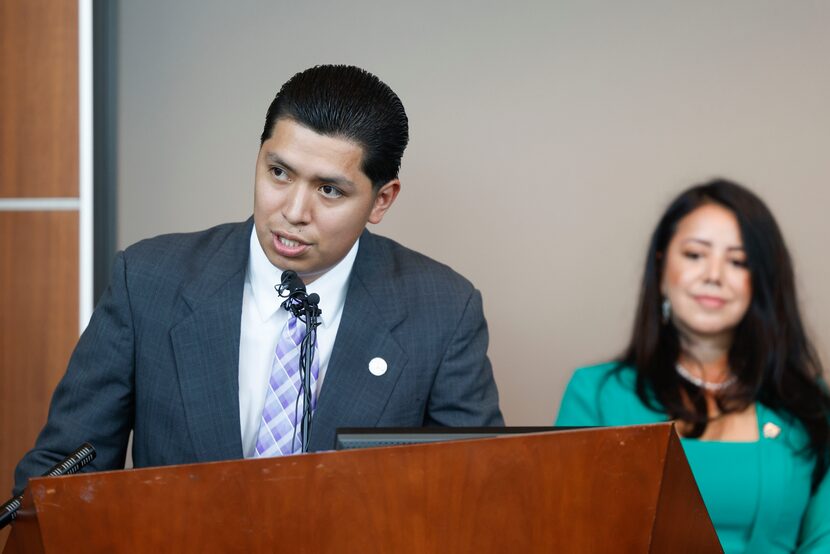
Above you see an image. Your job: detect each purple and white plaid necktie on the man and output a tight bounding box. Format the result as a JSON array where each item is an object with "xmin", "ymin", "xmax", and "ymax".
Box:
[{"xmin": 254, "ymin": 316, "xmax": 320, "ymax": 458}]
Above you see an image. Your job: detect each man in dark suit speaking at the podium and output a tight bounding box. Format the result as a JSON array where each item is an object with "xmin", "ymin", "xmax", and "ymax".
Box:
[{"xmin": 15, "ymin": 66, "xmax": 503, "ymax": 492}]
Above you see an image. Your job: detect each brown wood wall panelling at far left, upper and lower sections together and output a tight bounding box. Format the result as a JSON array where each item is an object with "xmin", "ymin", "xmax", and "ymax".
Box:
[{"xmin": 0, "ymin": 0, "xmax": 79, "ymax": 547}]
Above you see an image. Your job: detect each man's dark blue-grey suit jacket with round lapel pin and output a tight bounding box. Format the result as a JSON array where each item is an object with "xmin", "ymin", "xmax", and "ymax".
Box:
[{"xmin": 15, "ymin": 219, "xmax": 503, "ymax": 492}]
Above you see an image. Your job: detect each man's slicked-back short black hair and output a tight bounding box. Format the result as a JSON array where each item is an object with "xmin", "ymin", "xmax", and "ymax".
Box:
[{"xmin": 260, "ymin": 65, "xmax": 409, "ymax": 188}]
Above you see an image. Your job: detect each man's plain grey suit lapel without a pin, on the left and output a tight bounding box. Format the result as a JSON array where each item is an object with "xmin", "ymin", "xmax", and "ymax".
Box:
[{"xmin": 170, "ymin": 219, "xmax": 252, "ymax": 462}]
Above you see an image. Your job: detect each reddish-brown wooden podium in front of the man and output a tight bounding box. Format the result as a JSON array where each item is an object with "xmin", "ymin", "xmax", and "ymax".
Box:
[{"xmin": 4, "ymin": 423, "xmax": 722, "ymax": 554}]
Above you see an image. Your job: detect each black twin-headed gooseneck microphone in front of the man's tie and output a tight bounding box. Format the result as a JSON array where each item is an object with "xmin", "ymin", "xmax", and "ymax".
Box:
[{"xmin": 275, "ymin": 270, "xmax": 322, "ymax": 452}]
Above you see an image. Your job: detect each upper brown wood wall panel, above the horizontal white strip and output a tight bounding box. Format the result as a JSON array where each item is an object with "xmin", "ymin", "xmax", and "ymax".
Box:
[{"xmin": 0, "ymin": 0, "xmax": 78, "ymax": 198}]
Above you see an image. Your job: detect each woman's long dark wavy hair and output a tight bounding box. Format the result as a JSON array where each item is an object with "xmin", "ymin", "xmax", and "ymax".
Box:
[{"xmin": 618, "ymin": 179, "xmax": 830, "ymax": 487}]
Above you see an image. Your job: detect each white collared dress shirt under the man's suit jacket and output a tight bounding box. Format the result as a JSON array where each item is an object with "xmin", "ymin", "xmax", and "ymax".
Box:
[{"xmin": 239, "ymin": 228, "xmax": 360, "ymax": 458}]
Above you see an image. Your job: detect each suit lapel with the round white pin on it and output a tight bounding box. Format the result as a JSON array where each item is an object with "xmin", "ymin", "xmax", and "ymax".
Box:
[{"xmin": 310, "ymin": 231, "xmax": 407, "ymax": 450}]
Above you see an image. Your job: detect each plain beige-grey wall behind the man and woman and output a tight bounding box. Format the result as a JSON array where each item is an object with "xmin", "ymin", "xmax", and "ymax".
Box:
[{"xmin": 118, "ymin": 0, "xmax": 830, "ymax": 425}]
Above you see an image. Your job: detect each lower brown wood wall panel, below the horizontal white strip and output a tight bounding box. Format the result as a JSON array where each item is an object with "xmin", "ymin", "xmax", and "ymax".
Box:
[{"xmin": 0, "ymin": 212, "xmax": 78, "ymax": 502}]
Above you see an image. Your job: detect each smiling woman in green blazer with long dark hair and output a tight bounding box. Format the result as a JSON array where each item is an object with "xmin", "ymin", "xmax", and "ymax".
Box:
[{"xmin": 556, "ymin": 180, "xmax": 830, "ymax": 553}]
